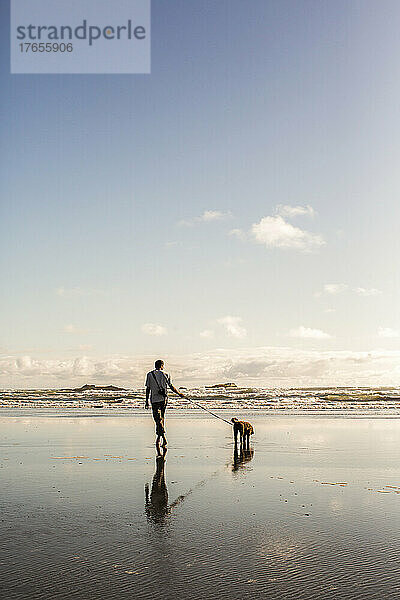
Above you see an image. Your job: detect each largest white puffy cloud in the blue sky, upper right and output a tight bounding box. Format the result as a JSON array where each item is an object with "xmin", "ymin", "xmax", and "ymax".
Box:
[{"xmin": 251, "ymin": 216, "xmax": 325, "ymax": 252}]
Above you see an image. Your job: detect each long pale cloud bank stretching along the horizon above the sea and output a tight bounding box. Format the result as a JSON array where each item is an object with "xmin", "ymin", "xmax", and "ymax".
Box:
[{"xmin": 0, "ymin": 347, "xmax": 400, "ymax": 388}]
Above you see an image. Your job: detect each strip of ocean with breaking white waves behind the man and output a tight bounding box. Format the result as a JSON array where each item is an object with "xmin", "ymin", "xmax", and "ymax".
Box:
[{"xmin": 0, "ymin": 386, "xmax": 400, "ymax": 414}]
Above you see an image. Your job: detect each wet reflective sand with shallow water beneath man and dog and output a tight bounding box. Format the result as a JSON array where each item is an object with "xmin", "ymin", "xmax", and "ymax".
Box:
[{"xmin": 0, "ymin": 410, "xmax": 400, "ymax": 600}]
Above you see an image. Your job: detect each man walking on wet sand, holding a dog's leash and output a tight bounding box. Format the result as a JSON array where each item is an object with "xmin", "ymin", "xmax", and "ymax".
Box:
[{"xmin": 145, "ymin": 360, "xmax": 184, "ymax": 453}]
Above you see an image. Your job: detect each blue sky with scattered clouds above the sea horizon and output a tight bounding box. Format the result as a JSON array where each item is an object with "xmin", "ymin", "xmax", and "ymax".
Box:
[{"xmin": 0, "ymin": 0, "xmax": 400, "ymax": 388}]
